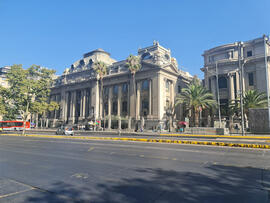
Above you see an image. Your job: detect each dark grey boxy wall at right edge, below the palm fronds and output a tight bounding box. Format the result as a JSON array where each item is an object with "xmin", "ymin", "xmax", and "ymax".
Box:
[{"xmin": 248, "ymin": 108, "xmax": 270, "ymax": 133}]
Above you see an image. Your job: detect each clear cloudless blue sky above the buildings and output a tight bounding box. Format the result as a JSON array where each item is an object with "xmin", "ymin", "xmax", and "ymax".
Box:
[{"xmin": 0, "ymin": 0, "xmax": 270, "ymax": 78}]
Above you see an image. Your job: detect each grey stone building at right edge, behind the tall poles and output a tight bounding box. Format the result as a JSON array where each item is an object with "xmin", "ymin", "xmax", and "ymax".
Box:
[{"xmin": 201, "ymin": 37, "xmax": 270, "ymax": 117}]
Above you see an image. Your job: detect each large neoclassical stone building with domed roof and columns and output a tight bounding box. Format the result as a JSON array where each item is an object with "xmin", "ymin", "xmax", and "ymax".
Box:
[{"xmin": 49, "ymin": 42, "xmax": 192, "ymax": 129}]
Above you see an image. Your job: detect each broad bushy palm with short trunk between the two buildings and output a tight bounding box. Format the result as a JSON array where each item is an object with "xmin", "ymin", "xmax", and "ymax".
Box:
[{"xmin": 175, "ymin": 82, "xmax": 217, "ymax": 127}]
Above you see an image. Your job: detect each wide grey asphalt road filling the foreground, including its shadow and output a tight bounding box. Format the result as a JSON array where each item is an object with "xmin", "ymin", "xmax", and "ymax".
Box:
[{"xmin": 0, "ymin": 136, "xmax": 270, "ymax": 203}]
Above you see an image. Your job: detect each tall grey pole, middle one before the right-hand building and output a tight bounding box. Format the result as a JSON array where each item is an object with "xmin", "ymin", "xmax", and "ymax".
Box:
[{"xmin": 238, "ymin": 42, "xmax": 245, "ymax": 136}]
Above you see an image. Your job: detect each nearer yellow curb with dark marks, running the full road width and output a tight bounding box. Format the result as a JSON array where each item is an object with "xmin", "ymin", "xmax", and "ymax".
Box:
[{"xmin": 0, "ymin": 134, "xmax": 270, "ymax": 149}]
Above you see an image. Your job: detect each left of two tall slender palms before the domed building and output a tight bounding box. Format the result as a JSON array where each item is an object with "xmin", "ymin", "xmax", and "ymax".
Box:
[{"xmin": 93, "ymin": 61, "xmax": 107, "ymax": 127}]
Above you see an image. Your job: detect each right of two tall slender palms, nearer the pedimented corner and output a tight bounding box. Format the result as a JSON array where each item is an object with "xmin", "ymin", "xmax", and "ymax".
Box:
[{"xmin": 126, "ymin": 54, "xmax": 142, "ymax": 123}]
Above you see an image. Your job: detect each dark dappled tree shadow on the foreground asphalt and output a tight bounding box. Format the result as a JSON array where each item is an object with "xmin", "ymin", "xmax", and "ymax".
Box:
[{"xmin": 27, "ymin": 165, "xmax": 270, "ymax": 203}]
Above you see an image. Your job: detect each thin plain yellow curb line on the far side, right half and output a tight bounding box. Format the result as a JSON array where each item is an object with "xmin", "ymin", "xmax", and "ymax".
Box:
[{"xmin": 160, "ymin": 134, "xmax": 270, "ymax": 139}]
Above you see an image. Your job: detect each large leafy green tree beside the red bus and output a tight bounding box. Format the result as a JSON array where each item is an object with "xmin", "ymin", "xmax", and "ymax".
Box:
[{"xmin": 7, "ymin": 65, "xmax": 55, "ymax": 134}]
